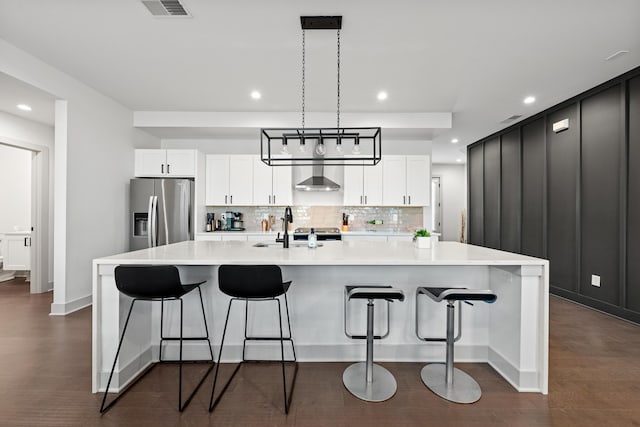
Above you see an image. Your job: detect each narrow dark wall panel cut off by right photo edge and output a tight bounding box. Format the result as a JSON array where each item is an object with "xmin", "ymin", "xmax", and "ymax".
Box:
[{"xmin": 626, "ymin": 77, "xmax": 640, "ymax": 312}]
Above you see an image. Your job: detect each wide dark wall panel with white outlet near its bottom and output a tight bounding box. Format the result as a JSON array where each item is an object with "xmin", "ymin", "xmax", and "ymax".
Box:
[{"xmin": 580, "ymin": 85, "xmax": 624, "ymax": 304}]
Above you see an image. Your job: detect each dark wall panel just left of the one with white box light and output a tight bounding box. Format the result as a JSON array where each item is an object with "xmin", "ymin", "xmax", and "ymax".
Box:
[{"xmin": 522, "ymin": 117, "xmax": 546, "ymax": 258}]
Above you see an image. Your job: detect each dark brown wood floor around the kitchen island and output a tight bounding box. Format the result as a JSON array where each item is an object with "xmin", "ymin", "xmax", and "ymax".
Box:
[{"xmin": 0, "ymin": 279, "xmax": 640, "ymax": 427}]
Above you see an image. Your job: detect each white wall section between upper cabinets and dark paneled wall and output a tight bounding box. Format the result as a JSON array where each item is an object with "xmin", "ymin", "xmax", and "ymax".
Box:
[{"xmin": 431, "ymin": 164, "xmax": 467, "ymax": 242}]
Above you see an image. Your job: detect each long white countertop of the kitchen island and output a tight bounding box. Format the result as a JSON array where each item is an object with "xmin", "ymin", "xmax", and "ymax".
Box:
[{"xmin": 94, "ymin": 240, "xmax": 548, "ymax": 265}]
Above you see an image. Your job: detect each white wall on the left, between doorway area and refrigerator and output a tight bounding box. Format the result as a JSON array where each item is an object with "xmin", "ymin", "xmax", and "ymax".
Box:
[{"xmin": 0, "ymin": 40, "xmax": 160, "ymax": 314}]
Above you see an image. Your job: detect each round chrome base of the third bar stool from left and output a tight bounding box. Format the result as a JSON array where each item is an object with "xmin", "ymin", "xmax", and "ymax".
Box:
[{"xmin": 342, "ymin": 362, "xmax": 398, "ymax": 402}]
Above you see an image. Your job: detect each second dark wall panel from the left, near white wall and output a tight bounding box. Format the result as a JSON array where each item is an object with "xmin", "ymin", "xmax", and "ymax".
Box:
[{"xmin": 484, "ymin": 138, "xmax": 500, "ymax": 249}]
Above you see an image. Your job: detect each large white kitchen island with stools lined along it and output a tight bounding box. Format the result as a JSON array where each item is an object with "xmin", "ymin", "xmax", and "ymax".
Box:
[{"xmin": 92, "ymin": 241, "xmax": 549, "ymax": 394}]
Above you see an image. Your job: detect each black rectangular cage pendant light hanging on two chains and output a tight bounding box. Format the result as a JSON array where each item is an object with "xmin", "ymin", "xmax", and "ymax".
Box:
[{"xmin": 260, "ymin": 16, "xmax": 382, "ymax": 166}]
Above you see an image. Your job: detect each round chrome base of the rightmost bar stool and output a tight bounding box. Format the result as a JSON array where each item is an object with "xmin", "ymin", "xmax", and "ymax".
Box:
[{"xmin": 420, "ymin": 363, "xmax": 482, "ymax": 403}]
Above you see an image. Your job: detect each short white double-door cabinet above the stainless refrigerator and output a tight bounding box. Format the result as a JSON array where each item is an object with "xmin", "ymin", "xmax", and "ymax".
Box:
[{"xmin": 134, "ymin": 149, "xmax": 196, "ymax": 178}]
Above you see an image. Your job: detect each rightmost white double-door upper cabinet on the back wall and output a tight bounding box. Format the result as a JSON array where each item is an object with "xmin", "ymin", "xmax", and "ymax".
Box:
[{"xmin": 382, "ymin": 156, "xmax": 431, "ymax": 206}]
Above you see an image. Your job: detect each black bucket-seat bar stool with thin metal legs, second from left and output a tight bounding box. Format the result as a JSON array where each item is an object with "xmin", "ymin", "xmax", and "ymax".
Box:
[{"xmin": 209, "ymin": 265, "xmax": 298, "ymax": 414}]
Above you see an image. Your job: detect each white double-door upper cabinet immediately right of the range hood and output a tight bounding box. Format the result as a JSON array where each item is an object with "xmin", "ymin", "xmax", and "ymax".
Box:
[{"xmin": 344, "ymin": 161, "xmax": 384, "ymax": 206}]
